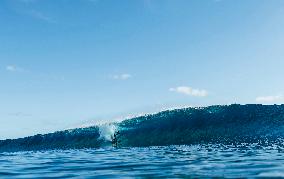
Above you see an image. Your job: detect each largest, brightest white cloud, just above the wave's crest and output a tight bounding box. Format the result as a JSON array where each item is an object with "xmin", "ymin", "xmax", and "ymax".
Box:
[{"xmin": 169, "ymin": 86, "xmax": 208, "ymax": 97}]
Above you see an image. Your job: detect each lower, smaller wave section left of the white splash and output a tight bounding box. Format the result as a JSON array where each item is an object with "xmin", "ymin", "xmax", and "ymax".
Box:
[{"xmin": 0, "ymin": 126, "xmax": 106, "ymax": 152}]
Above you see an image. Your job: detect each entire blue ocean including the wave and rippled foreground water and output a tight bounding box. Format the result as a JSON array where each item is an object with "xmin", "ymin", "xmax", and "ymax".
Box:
[{"xmin": 0, "ymin": 104, "xmax": 284, "ymax": 178}]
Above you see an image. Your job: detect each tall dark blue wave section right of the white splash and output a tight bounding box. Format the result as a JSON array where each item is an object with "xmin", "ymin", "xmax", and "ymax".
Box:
[{"xmin": 119, "ymin": 104, "xmax": 284, "ymax": 147}]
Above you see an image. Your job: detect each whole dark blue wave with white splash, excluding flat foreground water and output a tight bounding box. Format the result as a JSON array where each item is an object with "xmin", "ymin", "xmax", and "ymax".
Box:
[{"xmin": 0, "ymin": 104, "xmax": 284, "ymax": 151}]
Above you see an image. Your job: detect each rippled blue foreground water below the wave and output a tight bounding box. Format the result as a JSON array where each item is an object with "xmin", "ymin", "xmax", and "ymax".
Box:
[{"xmin": 0, "ymin": 144, "xmax": 284, "ymax": 178}]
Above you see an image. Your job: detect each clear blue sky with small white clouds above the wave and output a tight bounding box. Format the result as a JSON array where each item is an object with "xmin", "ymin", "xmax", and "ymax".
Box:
[{"xmin": 0, "ymin": 0, "xmax": 284, "ymax": 139}]
